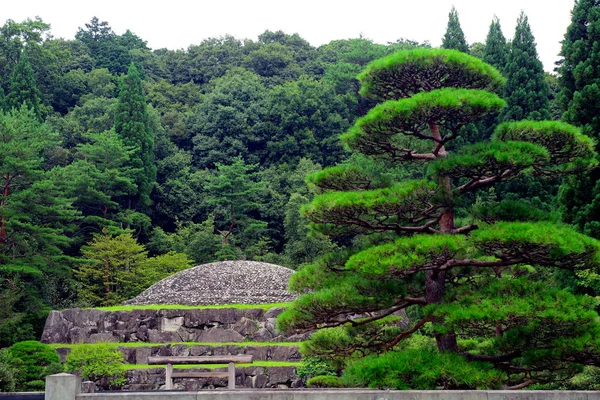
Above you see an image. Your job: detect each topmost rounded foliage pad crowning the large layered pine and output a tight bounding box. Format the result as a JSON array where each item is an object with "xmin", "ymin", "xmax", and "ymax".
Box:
[{"xmin": 358, "ymin": 49, "xmax": 504, "ymax": 100}]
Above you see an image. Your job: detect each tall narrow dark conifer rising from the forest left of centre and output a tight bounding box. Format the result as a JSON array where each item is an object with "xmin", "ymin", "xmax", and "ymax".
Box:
[{"xmin": 115, "ymin": 63, "xmax": 156, "ymax": 210}]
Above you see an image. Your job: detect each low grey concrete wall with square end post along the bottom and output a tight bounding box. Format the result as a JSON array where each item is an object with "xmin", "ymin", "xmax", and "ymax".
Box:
[{"xmin": 45, "ymin": 374, "xmax": 600, "ymax": 400}]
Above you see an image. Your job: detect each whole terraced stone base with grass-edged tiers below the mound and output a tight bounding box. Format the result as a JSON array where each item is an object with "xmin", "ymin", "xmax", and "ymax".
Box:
[{"xmin": 42, "ymin": 307, "xmax": 305, "ymax": 390}]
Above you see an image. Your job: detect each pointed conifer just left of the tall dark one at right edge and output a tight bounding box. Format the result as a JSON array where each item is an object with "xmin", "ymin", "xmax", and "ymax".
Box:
[{"xmin": 500, "ymin": 12, "xmax": 550, "ymax": 121}]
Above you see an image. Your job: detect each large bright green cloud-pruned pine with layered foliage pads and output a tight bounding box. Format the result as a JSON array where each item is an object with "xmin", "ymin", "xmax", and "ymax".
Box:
[{"xmin": 278, "ymin": 49, "xmax": 600, "ymax": 388}]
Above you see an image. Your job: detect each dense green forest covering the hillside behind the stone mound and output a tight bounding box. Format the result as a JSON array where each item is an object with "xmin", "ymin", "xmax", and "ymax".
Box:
[{"xmin": 0, "ymin": 0, "xmax": 600, "ymax": 388}]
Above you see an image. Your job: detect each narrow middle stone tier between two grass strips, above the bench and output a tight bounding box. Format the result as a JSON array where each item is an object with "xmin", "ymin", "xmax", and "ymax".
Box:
[{"xmin": 56, "ymin": 343, "xmax": 302, "ymax": 364}]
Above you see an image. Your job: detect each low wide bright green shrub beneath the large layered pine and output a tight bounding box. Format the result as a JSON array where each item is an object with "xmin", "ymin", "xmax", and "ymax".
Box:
[{"xmin": 342, "ymin": 350, "xmax": 503, "ymax": 390}]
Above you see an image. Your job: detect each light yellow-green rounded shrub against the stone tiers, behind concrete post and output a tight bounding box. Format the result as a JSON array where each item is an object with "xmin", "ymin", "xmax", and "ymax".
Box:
[{"xmin": 65, "ymin": 343, "xmax": 125, "ymax": 389}]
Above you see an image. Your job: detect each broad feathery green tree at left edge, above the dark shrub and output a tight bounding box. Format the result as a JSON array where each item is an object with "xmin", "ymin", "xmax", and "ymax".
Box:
[{"xmin": 0, "ymin": 105, "xmax": 79, "ymax": 345}]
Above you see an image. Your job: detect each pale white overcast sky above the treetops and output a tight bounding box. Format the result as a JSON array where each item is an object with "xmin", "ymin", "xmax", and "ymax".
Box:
[{"xmin": 0, "ymin": 0, "xmax": 574, "ymax": 71}]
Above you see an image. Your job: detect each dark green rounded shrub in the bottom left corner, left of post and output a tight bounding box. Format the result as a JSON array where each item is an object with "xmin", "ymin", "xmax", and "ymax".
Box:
[{"xmin": 8, "ymin": 340, "xmax": 62, "ymax": 391}]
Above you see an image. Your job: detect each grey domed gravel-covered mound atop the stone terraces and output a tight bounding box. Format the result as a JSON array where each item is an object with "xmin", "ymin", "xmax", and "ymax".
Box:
[{"xmin": 124, "ymin": 261, "xmax": 296, "ymax": 305}]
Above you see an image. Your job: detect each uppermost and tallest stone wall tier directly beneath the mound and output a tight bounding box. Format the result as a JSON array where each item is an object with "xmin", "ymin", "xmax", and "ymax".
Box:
[{"xmin": 41, "ymin": 307, "xmax": 306, "ymax": 344}]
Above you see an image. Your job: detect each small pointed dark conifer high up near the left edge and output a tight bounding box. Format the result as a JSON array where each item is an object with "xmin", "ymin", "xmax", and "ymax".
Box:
[{"xmin": 6, "ymin": 51, "xmax": 42, "ymax": 121}]
